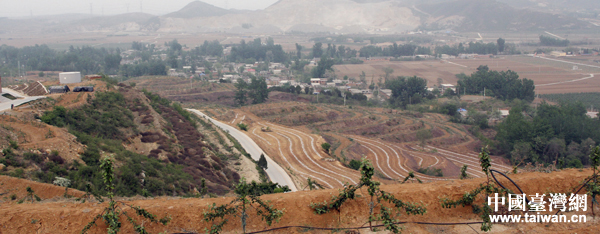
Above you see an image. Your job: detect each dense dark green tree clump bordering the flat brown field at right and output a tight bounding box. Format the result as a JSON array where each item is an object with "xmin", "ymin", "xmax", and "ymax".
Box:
[{"xmin": 457, "ymin": 66, "xmax": 535, "ymax": 101}]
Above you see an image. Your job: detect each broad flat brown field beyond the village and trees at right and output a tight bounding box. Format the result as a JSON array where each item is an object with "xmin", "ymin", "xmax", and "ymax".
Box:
[{"xmin": 334, "ymin": 56, "xmax": 600, "ymax": 94}]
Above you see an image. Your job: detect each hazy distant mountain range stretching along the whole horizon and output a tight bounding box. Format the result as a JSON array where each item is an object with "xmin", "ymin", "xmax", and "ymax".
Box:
[{"xmin": 0, "ymin": 0, "xmax": 600, "ymax": 34}]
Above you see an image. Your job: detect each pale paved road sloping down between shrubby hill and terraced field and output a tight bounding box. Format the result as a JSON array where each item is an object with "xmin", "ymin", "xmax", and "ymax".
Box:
[{"xmin": 187, "ymin": 109, "xmax": 298, "ymax": 192}]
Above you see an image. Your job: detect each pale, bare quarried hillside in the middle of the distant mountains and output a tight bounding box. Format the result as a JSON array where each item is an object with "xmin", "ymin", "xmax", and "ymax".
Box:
[{"xmin": 161, "ymin": 0, "xmax": 420, "ymax": 33}]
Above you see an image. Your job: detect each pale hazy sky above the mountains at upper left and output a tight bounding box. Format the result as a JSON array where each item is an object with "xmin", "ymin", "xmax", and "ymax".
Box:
[{"xmin": 0, "ymin": 0, "xmax": 277, "ymax": 17}]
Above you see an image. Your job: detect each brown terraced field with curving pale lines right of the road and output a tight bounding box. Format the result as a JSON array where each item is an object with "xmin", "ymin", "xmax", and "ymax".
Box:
[{"xmin": 207, "ymin": 102, "xmax": 511, "ymax": 189}]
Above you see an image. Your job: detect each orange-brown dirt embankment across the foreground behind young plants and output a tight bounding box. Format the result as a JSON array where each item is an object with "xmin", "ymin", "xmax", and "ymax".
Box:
[{"xmin": 0, "ymin": 169, "xmax": 600, "ymax": 234}]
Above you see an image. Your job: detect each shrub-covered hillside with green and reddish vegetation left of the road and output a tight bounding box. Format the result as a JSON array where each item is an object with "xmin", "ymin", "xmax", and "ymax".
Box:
[{"xmin": 0, "ymin": 84, "xmax": 258, "ymax": 196}]
